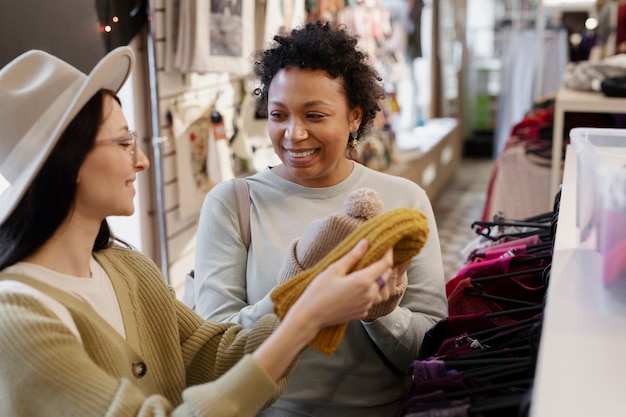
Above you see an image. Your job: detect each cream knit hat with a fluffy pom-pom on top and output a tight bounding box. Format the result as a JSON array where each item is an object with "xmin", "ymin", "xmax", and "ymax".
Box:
[{"xmin": 278, "ymin": 188, "xmax": 408, "ymax": 321}]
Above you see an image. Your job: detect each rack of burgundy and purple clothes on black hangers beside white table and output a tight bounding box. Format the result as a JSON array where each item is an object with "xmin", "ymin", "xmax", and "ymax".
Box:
[{"xmin": 403, "ymin": 195, "xmax": 560, "ymax": 417}]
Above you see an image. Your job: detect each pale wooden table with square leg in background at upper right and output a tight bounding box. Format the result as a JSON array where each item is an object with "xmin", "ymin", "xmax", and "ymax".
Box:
[{"xmin": 550, "ymin": 87, "xmax": 626, "ymax": 204}]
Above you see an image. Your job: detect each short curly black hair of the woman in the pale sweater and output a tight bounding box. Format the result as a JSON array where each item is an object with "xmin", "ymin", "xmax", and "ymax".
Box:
[{"xmin": 254, "ymin": 21, "xmax": 385, "ymax": 136}]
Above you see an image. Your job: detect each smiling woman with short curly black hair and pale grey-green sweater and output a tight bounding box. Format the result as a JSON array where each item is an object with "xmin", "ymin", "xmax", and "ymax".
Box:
[{"xmin": 194, "ymin": 22, "xmax": 447, "ymax": 417}]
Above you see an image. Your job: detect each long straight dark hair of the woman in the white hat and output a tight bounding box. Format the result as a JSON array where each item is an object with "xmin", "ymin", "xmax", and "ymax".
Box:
[{"xmin": 0, "ymin": 90, "xmax": 119, "ymax": 270}]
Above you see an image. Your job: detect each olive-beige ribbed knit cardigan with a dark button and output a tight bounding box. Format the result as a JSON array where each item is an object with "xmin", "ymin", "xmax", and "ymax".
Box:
[{"xmin": 0, "ymin": 246, "xmax": 286, "ymax": 417}]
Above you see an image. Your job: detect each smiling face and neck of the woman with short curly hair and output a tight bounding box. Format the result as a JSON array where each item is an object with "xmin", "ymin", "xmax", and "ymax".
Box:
[{"xmin": 267, "ymin": 67, "xmax": 363, "ymax": 188}]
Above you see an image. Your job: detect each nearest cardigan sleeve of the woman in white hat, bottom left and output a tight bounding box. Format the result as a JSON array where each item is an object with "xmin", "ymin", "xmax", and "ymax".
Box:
[{"xmin": 0, "ymin": 294, "xmax": 276, "ymax": 417}]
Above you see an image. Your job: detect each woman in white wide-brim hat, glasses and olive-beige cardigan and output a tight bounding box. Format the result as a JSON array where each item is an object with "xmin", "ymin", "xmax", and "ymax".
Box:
[{"xmin": 0, "ymin": 47, "xmax": 392, "ymax": 417}]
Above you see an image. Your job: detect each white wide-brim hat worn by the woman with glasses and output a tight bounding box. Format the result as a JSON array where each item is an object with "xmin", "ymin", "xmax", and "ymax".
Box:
[{"xmin": 0, "ymin": 46, "xmax": 135, "ymax": 224}]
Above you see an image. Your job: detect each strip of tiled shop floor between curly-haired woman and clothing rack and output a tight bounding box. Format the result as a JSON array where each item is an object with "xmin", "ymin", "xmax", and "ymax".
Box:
[{"xmin": 432, "ymin": 158, "xmax": 494, "ymax": 279}]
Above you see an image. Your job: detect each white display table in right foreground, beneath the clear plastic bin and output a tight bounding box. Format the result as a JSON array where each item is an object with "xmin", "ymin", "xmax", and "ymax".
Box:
[{"xmin": 530, "ymin": 145, "xmax": 626, "ymax": 417}]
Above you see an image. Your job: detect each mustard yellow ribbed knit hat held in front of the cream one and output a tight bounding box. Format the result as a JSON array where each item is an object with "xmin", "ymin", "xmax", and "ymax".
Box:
[{"xmin": 270, "ymin": 207, "xmax": 429, "ymax": 355}]
